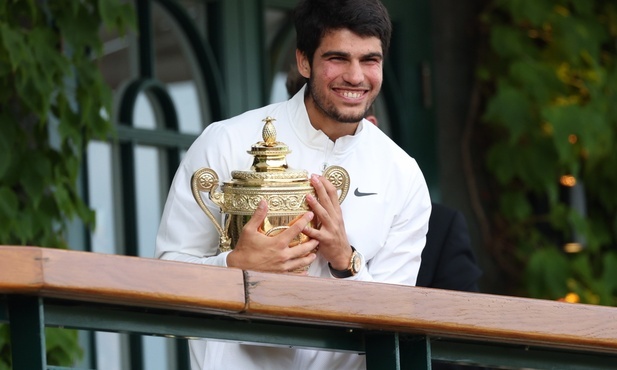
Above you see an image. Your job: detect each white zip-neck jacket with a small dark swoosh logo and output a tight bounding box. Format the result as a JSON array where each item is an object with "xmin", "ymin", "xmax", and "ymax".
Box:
[{"xmin": 156, "ymin": 88, "xmax": 431, "ymax": 370}]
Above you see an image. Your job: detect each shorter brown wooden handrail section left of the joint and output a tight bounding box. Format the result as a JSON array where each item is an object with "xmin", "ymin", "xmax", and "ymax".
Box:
[{"xmin": 0, "ymin": 247, "xmax": 245, "ymax": 313}]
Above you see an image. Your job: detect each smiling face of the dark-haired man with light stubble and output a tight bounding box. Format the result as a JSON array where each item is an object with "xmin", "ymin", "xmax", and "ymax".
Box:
[{"xmin": 297, "ymin": 29, "xmax": 383, "ymax": 125}]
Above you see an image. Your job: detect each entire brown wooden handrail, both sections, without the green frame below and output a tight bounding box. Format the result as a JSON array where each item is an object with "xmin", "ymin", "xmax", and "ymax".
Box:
[{"xmin": 0, "ymin": 246, "xmax": 617, "ymax": 353}]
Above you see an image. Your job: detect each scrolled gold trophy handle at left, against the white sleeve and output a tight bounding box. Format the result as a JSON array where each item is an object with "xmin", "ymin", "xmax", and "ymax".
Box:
[{"xmin": 191, "ymin": 168, "xmax": 231, "ymax": 251}]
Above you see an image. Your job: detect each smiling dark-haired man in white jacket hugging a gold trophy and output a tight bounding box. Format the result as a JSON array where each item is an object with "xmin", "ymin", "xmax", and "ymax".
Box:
[{"xmin": 156, "ymin": 0, "xmax": 431, "ymax": 369}]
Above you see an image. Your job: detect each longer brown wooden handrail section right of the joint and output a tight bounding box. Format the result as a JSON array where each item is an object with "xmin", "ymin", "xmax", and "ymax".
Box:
[{"xmin": 246, "ymin": 272, "xmax": 617, "ymax": 352}]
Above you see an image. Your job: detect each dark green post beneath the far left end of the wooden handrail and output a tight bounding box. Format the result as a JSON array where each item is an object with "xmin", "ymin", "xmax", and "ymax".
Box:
[{"xmin": 8, "ymin": 296, "xmax": 47, "ymax": 370}]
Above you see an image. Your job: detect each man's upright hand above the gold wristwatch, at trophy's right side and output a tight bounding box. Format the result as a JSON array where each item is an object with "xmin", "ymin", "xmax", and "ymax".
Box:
[{"xmin": 304, "ymin": 175, "xmax": 353, "ymax": 270}]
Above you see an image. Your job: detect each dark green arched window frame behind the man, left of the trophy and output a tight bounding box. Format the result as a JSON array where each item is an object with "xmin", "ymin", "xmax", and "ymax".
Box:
[{"xmin": 107, "ymin": 0, "xmax": 228, "ymax": 370}]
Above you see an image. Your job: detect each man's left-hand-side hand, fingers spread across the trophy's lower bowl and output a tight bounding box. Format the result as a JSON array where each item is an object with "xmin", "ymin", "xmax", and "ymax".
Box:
[{"xmin": 227, "ymin": 200, "xmax": 318, "ymax": 274}]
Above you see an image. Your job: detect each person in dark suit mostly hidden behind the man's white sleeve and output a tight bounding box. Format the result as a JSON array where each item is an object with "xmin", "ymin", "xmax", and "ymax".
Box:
[{"xmin": 416, "ymin": 202, "xmax": 482, "ymax": 292}]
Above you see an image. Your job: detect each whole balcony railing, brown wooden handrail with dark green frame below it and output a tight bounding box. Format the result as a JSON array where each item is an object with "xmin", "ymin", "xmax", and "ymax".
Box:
[{"xmin": 0, "ymin": 246, "xmax": 617, "ymax": 370}]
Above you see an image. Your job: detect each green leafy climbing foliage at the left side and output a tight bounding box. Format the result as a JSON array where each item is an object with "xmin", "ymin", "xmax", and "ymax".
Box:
[{"xmin": 0, "ymin": 0, "xmax": 134, "ymax": 369}]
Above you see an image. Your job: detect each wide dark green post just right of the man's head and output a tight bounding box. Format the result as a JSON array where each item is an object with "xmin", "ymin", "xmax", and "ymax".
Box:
[{"xmin": 382, "ymin": 0, "xmax": 439, "ymax": 198}]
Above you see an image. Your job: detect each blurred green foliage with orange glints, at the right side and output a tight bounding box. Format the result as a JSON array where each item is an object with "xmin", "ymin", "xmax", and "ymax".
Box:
[{"xmin": 478, "ymin": 0, "xmax": 617, "ymax": 305}]
